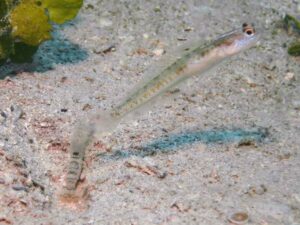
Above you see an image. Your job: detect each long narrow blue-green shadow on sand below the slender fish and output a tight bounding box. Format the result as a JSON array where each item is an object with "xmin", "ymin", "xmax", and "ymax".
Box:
[{"xmin": 99, "ymin": 128, "xmax": 269, "ymax": 159}]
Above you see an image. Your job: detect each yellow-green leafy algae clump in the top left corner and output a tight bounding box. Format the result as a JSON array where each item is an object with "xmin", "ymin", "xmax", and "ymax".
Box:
[{"xmin": 0, "ymin": 0, "xmax": 83, "ymax": 65}]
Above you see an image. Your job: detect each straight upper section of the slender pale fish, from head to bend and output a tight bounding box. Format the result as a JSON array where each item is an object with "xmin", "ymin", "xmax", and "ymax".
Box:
[{"xmin": 96, "ymin": 23, "xmax": 258, "ymax": 133}]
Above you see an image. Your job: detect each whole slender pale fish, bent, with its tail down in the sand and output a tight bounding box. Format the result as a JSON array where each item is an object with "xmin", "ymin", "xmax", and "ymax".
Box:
[{"xmin": 66, "ymin": 23, "xmax": 258, "ymax": 192}]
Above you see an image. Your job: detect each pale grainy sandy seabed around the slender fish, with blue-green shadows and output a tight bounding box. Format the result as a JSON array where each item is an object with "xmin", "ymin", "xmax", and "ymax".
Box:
[{"xmin": 0, "ymin": 0, "xmax": 300, "ymax": 225}]
